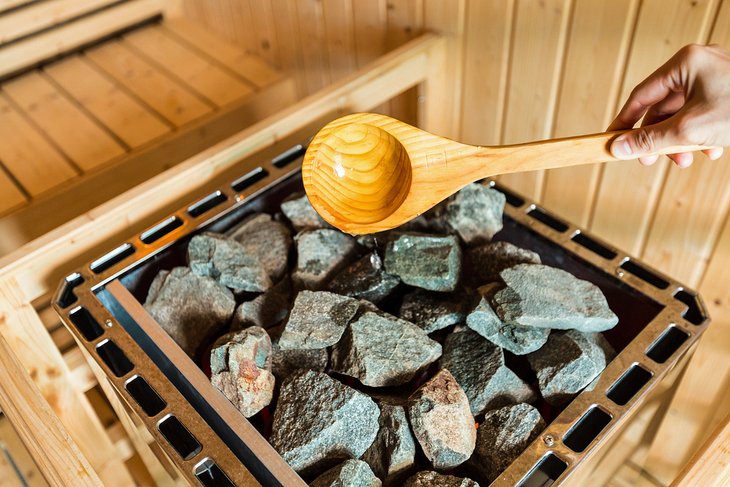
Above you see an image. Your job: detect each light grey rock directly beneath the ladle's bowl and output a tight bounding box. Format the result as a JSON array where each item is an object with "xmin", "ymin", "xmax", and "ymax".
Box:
[{"xmin": 292, "ymin": 229, "xmax": 357, "ymax": 290}]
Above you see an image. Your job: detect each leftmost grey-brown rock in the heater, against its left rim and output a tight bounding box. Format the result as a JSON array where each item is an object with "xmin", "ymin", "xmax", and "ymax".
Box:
[{"xmin": 144, "ymin": 267, "xmax": 236, "ymax": 358}]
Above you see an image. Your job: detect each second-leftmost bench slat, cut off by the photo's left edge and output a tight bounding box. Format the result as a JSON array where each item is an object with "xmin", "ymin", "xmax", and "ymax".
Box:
[{"xmin": 0, "ymin": 93, "xmax": 77, "ymax": 196}]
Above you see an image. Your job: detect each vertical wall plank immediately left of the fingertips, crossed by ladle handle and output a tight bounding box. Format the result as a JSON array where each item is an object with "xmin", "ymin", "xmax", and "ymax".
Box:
[{"xmin": 542, "ymin": 0, "xmax": 639, "ymax": 226}]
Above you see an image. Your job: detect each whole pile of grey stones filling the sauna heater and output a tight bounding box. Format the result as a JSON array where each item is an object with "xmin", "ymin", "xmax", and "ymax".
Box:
[{"xmin": 145, "ymin": 184, "xmax": 618, "ymax": 486}]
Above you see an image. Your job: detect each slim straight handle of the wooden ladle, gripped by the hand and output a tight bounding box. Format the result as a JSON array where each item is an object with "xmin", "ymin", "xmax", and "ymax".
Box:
[{"xmin": 485, "ymin": 130, "xmax": 712, "ymax": 174}]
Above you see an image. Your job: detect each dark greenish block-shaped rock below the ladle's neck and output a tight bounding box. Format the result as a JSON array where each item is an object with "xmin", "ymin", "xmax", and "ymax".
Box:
[{"xmin": 385, "ymin": 234, "xmax": 461, "ymax": 291}]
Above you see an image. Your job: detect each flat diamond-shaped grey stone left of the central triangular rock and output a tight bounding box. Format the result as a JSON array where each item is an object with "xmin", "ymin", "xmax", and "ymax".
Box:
[{"xmin": 279, "ymin": 291, "xmax": 360, "ymax": 350}]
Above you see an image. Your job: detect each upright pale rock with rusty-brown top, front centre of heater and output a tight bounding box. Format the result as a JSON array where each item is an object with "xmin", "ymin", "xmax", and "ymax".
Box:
[{"xmin": 408, "ymin": 369, "xmax": 477, "ymax": 469}]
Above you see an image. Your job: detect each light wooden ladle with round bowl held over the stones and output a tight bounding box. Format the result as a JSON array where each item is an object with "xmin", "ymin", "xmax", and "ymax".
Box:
[{"xmin": 302, "ymin": 113, "xmax": 708, "ymax": 235}]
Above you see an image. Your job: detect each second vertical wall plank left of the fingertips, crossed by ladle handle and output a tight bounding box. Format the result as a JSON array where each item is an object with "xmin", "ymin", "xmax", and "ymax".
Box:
[{"xmin": 500, "ymin": 0, "xmax": 572, "ymax": 200}]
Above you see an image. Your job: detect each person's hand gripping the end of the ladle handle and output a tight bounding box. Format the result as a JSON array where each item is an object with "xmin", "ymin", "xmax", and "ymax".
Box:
[{"xmin": 608, "ymin": 44, "xmax": 730, "ymax": 167}]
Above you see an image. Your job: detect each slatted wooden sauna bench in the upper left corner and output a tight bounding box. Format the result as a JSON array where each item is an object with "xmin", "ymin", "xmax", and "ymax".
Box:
[{"xmin": 0, "ymin": 0, "xmax": 295, "ymax": 255}]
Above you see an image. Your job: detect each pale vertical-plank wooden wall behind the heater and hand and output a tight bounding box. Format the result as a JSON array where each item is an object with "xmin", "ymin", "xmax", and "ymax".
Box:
[{"xmin": 182, "ymin": 0, "xmax": 730, "ymax": 483}]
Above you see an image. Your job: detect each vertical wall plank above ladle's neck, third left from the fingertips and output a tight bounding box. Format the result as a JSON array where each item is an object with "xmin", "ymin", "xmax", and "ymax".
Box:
[{"xmin": 461, "ymin": 0, "xmax": 514, "ymax": 145}]
